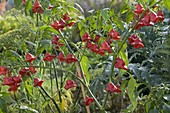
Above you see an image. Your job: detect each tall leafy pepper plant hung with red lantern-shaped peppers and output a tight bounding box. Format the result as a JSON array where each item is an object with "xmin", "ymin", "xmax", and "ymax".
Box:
[{"xmin": 0, "ymin": 0, "xmax": 170, "ymax": 113}]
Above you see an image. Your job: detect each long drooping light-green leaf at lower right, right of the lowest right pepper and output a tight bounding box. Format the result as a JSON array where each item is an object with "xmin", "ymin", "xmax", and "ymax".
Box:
[{"xmin": 127, "ymin": 76, "xmax": 137, "ymax": 112}]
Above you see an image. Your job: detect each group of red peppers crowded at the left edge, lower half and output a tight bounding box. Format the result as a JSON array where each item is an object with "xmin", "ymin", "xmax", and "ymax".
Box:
[{"xmin": 0, "ymin": 53, "xmax": 43, "ymax": 91}]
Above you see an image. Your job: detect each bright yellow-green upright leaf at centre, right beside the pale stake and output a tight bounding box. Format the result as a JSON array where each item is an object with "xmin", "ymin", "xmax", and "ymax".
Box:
[{"xmin": 80, "ymin": 56, "xmax": 90, "ymax": 83}]
